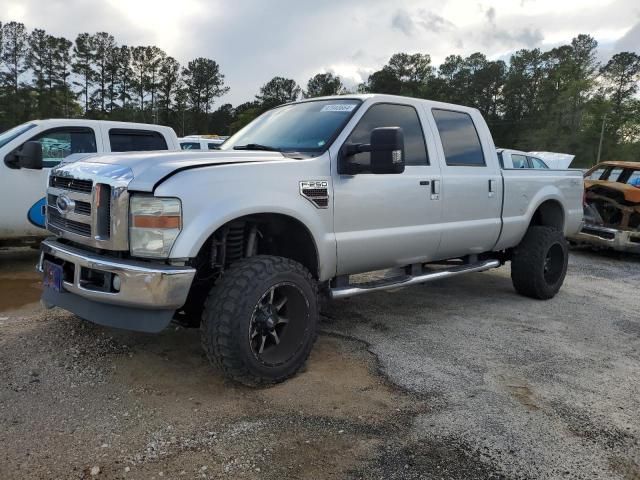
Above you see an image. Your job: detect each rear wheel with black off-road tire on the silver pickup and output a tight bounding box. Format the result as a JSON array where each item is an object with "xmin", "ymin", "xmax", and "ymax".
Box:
[{"xmin": 511, "ymin": 226, "xmax": 569, "ymax": 300}]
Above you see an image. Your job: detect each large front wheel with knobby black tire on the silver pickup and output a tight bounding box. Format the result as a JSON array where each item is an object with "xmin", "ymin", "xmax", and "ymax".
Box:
[{"xmin": 200, "ymin": 255, "xmax": 318, "ymax": 386}]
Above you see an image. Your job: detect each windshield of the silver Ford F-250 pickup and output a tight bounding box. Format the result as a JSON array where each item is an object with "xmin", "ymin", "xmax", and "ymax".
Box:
[{"xmin": 220, "ymin": 99, "xmax": 362, "ymax": 154}]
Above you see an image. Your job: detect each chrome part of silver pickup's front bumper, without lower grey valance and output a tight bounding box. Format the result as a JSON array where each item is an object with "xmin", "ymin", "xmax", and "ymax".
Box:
[{"xmin": 37, "ymin": 239, "xmax": 196, "ymax": 310}]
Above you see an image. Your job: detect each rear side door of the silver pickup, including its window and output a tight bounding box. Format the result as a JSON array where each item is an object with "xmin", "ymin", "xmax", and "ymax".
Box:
[{"xmin": 429, "ymin": 108, "xmax": 502, "ymax": 259}]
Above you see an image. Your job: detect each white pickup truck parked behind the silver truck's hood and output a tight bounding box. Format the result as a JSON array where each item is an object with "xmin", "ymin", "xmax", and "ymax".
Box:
[{"xmin": 0, "ymin": 118, "xmax": 180, "ymax": 245}]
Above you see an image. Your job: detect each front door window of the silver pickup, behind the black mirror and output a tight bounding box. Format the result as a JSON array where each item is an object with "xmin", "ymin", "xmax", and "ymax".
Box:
[{"xmin": 346, "ymin": 103, "xmax": 429, "ymax": 173}]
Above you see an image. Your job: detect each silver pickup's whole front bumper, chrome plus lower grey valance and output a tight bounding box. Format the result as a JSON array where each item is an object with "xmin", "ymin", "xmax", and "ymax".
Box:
[{"xmin": 38, "ymin": 239, "xmax": 196, "ymax": 331}]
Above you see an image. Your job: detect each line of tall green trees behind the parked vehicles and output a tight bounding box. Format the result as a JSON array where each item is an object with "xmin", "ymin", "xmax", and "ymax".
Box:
[{"xmin": 0, "ymin": 22, "xmax": 640, "ymax": 166}]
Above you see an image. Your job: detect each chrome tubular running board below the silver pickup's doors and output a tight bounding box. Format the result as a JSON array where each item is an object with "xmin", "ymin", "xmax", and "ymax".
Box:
[{"xmin": 330, "ymin": 260, "xmax": 500, "ymax": 300}]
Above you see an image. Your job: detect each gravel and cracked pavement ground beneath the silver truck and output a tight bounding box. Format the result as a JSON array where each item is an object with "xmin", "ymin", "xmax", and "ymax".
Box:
[{"xmin": 0, "ymin": 246, "xmax": 640, "ymax": 480}]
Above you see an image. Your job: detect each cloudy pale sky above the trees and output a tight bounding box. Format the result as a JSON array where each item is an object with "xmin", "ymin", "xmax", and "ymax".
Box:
[{"xmin": 0, "ymin": 0, "xmax": 640, "ymax": 105}]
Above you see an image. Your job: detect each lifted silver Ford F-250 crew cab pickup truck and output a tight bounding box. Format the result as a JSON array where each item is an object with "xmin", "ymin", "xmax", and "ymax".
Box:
[{"xmin": 39, "ymin": 95, "xmax": 583, "ymax": 385}]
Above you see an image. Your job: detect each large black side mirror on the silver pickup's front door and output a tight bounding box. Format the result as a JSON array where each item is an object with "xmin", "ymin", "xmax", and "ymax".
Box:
[{"xmin": 339, "ymin": 127, "xmax": 404, "ymax": 175}]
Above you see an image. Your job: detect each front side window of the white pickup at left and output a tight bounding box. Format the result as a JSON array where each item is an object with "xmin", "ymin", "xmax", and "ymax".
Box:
[{"xmin": 30, "ymin": 127, "xmax": 98, "ymax": 168}]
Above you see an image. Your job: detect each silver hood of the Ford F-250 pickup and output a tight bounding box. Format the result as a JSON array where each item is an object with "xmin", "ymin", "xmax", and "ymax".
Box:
[{"xmin": 54, "ymin": 150, "xmax": 289, "ymax": 192}]
